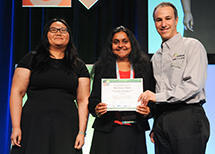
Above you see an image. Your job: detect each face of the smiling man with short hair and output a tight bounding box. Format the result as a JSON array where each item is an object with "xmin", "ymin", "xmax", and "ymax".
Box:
[{"xmin": 154, "ymin": 6, "xmax": 178, "ymax": 42}]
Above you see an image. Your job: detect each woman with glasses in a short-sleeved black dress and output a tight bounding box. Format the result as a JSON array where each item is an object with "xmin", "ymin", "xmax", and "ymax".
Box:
[{"xmin": 10, "ymin": 19, "xmax": 90, "ymax": 154}]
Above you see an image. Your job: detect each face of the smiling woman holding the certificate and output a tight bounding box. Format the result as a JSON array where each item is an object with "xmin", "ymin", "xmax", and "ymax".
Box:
[{"xmin": 112, "ymin": 31, "xmax": 132, "ymax": 60}]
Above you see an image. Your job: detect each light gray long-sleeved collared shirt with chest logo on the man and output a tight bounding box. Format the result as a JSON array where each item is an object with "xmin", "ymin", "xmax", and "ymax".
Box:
[{"xmin": 151, "ymin": 33, "xmax": 208, "ymax": 104}]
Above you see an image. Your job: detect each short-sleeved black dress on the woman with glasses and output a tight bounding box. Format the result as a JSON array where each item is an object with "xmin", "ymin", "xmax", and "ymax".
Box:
[{"xmin": 11, "ymin": 53, "xmax": 89, "ymax": 154}]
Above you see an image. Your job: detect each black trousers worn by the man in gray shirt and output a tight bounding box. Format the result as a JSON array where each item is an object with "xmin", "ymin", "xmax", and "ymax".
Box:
[{"xmin": 154, "ymin": 104, "xmax": 210, "ymax": 154}]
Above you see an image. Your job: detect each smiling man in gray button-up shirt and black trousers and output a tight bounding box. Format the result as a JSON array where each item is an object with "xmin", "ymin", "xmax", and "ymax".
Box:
[{"xmin": 139, "ymin": 2, "xmax": 210, "ymax": 154}]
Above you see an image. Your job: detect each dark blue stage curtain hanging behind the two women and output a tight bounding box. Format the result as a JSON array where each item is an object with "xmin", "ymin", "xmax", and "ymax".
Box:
[{"xmin": 0, "ymin": 0, "xmax": 215, "ymax": 154}]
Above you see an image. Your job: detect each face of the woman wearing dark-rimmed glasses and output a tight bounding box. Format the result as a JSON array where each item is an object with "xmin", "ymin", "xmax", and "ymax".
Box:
[{"xmin": 47, "ymin": 21, "xmax": 70, "ymax": 49}]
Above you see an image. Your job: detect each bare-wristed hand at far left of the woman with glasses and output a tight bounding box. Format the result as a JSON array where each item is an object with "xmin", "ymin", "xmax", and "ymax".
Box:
[{"xmin": 11, "ymin": 128, "xmax": 22, "ymax": 147}]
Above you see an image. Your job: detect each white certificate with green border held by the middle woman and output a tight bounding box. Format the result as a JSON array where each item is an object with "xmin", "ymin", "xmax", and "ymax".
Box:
[{"xmin": 101, "ymin": 78, "xmax": 143, "ymax": 111}]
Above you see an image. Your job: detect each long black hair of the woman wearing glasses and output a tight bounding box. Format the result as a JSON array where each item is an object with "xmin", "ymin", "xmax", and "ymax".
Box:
[{"xmin": 31, "ymin": 18, "xmax": 79, "ymax": 73}]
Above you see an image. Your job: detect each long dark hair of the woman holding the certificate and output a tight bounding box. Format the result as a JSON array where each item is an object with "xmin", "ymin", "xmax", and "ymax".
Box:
[{"xmin": 91, "ymin": 26, "xmax": 151, "ymax": 77}]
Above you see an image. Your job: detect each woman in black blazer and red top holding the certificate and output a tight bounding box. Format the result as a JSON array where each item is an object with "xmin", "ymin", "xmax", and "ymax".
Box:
[{"xmin": 88, "ymin": 26, "xmax": 153, "ymax": 154}]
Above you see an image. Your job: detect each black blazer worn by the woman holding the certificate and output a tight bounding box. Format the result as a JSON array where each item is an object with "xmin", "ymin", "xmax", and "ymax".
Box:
[{"xmin": 88, "ymin": 66, "xmax": 154, "ymax": 132}]
